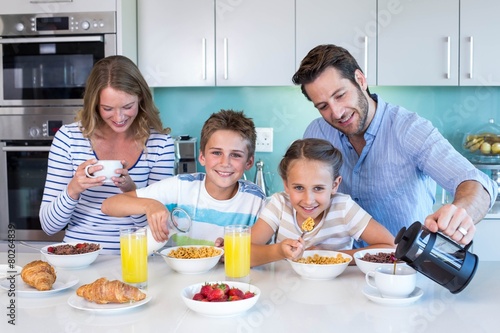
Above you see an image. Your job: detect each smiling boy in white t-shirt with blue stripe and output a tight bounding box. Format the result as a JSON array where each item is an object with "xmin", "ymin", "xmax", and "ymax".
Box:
[{"xmin": 101, "ymin": 110, "xmax": 266, "ymax": 246}]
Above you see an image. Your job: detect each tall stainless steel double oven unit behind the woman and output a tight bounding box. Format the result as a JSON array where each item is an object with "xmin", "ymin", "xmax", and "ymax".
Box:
[{"xmin": 0, "ymin": 0, "xmax": 132, "ymax": 240}]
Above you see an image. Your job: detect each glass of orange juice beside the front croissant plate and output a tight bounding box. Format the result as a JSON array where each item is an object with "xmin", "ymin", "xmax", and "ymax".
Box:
[{"xmin": 120, "ymin": 227, "xmax": 148, "ymax": 289}]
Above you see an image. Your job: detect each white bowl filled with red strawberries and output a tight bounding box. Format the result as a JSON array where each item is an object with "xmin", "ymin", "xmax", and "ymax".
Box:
[{"xmin": 181, "ymin": 281, "xmax": 260, "ymax": 317}]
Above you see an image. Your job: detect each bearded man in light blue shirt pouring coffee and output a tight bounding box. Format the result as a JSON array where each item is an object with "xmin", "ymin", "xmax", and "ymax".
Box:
[{"xmin": 293, "ymin": 45, "xmax": 498, "ymax": 244}]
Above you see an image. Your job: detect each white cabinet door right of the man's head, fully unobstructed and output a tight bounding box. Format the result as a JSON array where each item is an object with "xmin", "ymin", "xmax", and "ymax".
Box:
[{"xmin": 377, "ymin": 0, "xmax": 459, "ymax": 86}]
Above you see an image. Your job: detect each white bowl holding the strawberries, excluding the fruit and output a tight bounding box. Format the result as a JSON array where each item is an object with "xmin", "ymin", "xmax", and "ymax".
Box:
[{"xmin": 181, "ymin": 281, "xmax": 260, "ymax": 317}]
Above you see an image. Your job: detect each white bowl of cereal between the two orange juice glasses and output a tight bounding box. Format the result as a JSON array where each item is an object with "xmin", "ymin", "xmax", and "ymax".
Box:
[{"xmin": 155, "ymin": 245, "xmax": 224, "ymax": 274}]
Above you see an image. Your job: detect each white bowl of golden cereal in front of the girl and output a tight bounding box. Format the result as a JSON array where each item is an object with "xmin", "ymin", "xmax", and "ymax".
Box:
[{"xmin": 287, "ymin": 250, "xmax": 352, "ymax": 280}]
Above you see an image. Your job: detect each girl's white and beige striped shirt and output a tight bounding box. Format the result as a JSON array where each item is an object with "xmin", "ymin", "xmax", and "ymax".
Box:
[{"xmin": 259, "ymin": 192, "xmax": 372, "ymax": 250}]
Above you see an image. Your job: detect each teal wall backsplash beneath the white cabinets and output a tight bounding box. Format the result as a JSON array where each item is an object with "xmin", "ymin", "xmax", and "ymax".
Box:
[{"xmin": 154, "ymin": 87, "xmax": 500, "ymax": 193}]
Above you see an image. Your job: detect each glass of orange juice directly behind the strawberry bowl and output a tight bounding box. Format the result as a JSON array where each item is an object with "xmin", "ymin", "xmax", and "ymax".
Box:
[{"xmin": 224, "ymin": 225, "xmax": 250, "ymax": 282}]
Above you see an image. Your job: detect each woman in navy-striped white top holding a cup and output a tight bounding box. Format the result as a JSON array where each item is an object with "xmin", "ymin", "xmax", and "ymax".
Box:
[{"xmin": 40, "ymin": 56, "xmax": 174, "ymax": 254}]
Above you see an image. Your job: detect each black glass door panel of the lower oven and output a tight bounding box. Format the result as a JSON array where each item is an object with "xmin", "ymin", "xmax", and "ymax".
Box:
[{"xmin": 7, "ymin": 145, "xmax": 48, "ymax": 230}]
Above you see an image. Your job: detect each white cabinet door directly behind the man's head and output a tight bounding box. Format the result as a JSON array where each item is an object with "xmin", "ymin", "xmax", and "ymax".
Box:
[{"xmin": 295, "ymin": 0, "xmax": 377, "ymax": 85}]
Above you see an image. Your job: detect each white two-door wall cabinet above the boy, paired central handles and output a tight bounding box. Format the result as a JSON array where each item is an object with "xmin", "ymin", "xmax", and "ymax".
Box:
[{"xmin": 138, "ymin": 0, "xmax": 295, "ymax": 87}]
